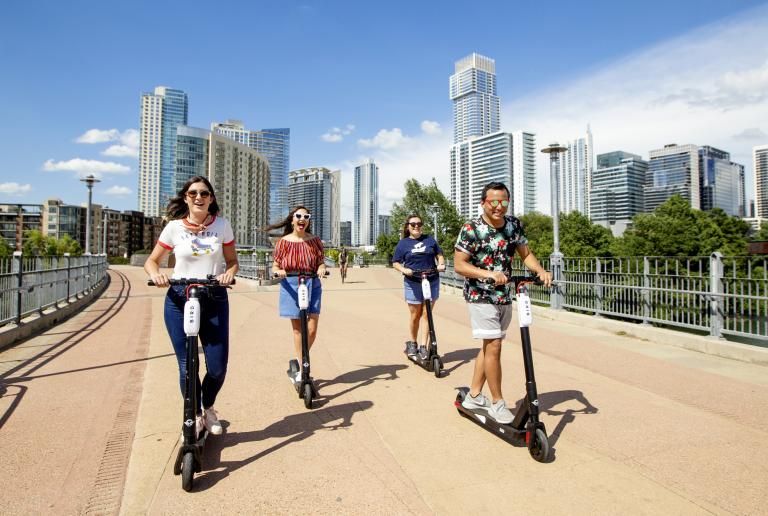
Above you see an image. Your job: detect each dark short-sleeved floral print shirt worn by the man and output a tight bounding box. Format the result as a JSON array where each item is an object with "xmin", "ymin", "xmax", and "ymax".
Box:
[{"xmin": 455, "ymin": 215, "xmax": 528, "ymax": 305}]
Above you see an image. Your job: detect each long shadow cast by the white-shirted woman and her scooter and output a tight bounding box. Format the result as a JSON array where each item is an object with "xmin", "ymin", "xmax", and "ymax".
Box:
[{"xmin": 195, "ymin": 401, "xmax": 373, "ymax": 491}]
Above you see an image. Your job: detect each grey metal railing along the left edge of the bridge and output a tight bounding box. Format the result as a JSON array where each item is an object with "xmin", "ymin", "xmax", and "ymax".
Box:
[{"xmin": 0, "ymin": 252, "xmax": 108, "ymax": 326}]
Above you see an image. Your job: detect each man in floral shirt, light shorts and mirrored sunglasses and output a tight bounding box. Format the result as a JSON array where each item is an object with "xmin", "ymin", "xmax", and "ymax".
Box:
[{"xmin": 454, "ymin": 182, "xmax": 552, "ymax": 424}]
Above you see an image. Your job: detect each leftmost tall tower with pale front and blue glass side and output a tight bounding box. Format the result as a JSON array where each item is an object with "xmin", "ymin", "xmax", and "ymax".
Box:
[{"xmin": 138, "ymin": 86, "xmax": 188, "ymax": 217}]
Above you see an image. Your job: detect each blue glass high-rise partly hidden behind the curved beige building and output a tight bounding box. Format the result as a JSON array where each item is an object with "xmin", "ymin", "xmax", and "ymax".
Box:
[{"xmin": 211, "ymin": 120, "xmax": 291, "ymax": 227}]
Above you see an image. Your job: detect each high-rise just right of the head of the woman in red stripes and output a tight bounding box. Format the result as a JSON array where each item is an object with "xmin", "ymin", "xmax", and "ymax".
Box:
[{"xmin": 288, "ymin": 167, "xmax": 341, "ymax": 246}]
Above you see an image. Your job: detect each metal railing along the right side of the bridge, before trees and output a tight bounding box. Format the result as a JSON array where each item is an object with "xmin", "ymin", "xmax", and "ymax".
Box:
[{"xmin": 441, "ymin": 253, "xmax": 768, "ymax": 340}]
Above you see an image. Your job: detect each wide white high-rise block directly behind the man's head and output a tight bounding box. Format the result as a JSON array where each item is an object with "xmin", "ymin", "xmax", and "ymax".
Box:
[{"xmin": 450, "ymin": 131, "xmax": 536, "ymax": 218}]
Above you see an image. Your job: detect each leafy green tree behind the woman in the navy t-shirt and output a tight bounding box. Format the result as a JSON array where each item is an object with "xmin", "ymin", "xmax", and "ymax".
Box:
[{"xmin": 376, "ymin": 178, "xmax": 463, "ymax": 258}]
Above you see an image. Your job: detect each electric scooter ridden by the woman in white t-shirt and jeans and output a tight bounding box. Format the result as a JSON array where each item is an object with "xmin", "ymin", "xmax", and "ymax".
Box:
[{"xmin": 147, "ymin": 274, "xmax": 234, "ymax": 491}]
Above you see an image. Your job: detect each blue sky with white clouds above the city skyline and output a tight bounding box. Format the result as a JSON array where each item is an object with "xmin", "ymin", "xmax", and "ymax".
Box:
[{"xmin": 0, "ymin": 0, "xmax": 768, "ymax": 218}]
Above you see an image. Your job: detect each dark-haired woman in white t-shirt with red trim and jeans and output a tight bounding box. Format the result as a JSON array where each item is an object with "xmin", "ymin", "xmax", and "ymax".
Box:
[{"xmin": 144, "ymin": 176, "xmax": 238, "ymax": 435}]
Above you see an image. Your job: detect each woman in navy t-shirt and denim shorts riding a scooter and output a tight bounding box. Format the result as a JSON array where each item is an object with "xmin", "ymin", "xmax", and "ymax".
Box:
[{"xmin": 392, "ymin": 214, "xmax": 445, "ymax": 356}]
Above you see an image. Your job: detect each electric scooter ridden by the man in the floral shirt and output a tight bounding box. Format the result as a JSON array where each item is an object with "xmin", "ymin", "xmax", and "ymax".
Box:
[{"xmin": 454, "ymin": 276, "xmax": 549, "ymax": 462}]
